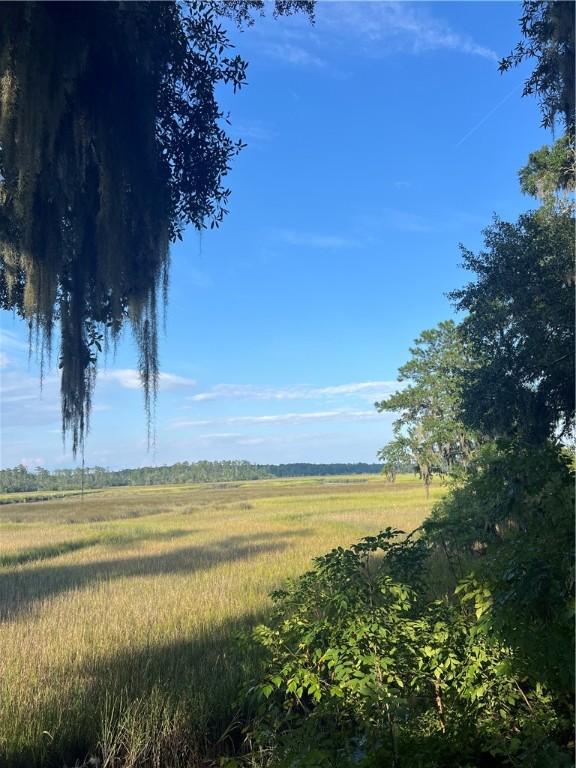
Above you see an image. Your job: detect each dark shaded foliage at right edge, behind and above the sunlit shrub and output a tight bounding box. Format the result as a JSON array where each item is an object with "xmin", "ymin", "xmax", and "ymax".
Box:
[{"xmin": 425, "ymin": 442, "xmax": 575, "ymax": 704}]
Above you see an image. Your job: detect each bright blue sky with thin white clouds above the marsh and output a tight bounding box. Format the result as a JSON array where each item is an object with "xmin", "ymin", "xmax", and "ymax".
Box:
[{"xmin": 0, "ymin": 1, "xmax": 550, "ymax": 468}]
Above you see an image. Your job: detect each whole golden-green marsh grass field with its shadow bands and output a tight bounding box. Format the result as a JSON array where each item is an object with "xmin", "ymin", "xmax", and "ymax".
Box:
[{"xmin": 0, "ymin": 476, "xmax": 443, "ymax": 768}]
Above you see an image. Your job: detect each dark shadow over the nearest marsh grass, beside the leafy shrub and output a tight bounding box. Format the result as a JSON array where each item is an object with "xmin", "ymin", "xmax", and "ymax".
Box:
[{"xmin": 0, "ymin": 612, "xmax": 272, "ymax": 768}]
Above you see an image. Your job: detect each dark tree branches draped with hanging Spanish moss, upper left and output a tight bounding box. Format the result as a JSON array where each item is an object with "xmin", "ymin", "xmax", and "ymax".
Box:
[{"xmin": 0, "ymin": 0, "xmax": 311, "ymax": 452}]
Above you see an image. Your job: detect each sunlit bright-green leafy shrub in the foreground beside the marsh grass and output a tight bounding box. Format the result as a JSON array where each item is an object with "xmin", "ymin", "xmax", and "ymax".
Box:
[{"xmin": 236, "ymin": 528, "xmax": 570, "ymax": 768}]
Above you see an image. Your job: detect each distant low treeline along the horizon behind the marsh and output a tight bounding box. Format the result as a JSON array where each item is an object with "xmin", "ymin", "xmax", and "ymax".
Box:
[{"xmin": 0, "ymin": 461, "xmax": 390, "ymax": 493}]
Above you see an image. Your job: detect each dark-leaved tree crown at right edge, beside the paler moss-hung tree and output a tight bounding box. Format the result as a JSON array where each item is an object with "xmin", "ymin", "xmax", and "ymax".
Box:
[{"xmin": 452, "ymin": 211, "xmax": 574, "ymax": 442}]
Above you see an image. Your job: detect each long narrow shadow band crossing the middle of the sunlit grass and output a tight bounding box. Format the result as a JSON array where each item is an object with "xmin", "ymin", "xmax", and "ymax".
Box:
[{"xmin": 0, "ymin": 530, "xmax": 308, "ymax": 620}]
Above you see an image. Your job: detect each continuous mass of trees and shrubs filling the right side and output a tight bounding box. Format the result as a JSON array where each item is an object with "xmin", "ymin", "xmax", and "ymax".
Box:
[{"xmin": 238, "ymin": 1, "xmax": 575, "ymax": 768}]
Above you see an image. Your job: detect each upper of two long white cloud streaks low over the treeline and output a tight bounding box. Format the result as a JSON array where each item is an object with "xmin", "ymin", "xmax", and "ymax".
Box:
[{"xmin": 186, "ymin": 381, "xmax": 400, "ymax": 403}]
